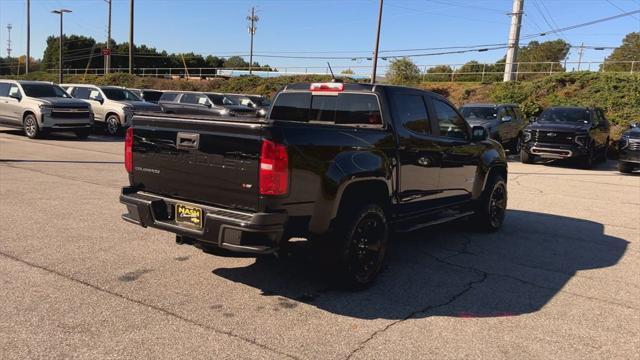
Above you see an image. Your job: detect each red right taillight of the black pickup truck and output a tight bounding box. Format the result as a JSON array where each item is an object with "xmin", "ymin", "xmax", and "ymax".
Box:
[{"xmin": 260, "ymin": 140, "xmax": 289, "ymax": 195}]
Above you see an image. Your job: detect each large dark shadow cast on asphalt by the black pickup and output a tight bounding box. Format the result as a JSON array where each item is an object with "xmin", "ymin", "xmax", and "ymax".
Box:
[{"xmin": 213, "ymin": 210, "xmax": 628, "ymax": 319}]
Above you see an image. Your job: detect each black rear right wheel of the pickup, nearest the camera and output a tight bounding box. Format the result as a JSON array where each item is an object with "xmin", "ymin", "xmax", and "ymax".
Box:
[{"xmin": 325, "ymin": 204, "xmax": 390, "ymax": 290}]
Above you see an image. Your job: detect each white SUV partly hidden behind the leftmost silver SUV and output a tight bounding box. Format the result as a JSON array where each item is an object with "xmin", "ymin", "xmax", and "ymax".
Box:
[{"xmin": 61, "ymin": 84, "xmax": 160, "ymax": 136}]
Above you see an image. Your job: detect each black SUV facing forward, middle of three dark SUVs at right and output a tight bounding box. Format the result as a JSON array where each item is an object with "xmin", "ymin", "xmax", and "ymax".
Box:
[{"xmin": 520, "ymin": 107, "xmax": 609, "ymax": 169}]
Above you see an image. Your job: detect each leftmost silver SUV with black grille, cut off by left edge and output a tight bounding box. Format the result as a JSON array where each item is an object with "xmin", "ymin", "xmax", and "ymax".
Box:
[{"xmin": 0, "ymin": 80, "xmax": 93, "ymax": 139}]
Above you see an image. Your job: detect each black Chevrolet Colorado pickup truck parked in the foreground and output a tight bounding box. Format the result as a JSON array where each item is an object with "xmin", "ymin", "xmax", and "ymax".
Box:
[{"xmin": 120, "ymin": 82, "xmax": 507, "ymax": 286}]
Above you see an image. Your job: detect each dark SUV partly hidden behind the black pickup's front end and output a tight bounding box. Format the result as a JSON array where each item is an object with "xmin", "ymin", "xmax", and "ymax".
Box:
[{"xmin": 460, "ymin": 104, "xmax": 528, "ymax": 154}]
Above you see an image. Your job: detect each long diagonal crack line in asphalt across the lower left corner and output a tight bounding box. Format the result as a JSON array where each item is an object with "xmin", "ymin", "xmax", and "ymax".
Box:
[{"xmin": 0, "ymin": 251, "xmax": 300, "ymax": 360}]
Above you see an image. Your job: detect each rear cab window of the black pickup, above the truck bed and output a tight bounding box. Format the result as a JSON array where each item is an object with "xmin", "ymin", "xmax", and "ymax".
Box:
[{"xmin": 271, "ymin": 91, "xmax": 383, "ymax": 127}]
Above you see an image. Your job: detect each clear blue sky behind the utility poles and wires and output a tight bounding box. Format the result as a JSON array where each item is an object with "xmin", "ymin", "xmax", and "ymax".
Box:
[{"xmin": 0, "ymin": 0, "xmax": 640, "ymax": 72}]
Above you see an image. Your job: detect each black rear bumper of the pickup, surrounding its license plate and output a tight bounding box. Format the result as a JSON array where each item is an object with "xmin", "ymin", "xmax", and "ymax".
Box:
[{"xmin": 120, "ymin": 187, "xmax": 287, "ymax": 254}]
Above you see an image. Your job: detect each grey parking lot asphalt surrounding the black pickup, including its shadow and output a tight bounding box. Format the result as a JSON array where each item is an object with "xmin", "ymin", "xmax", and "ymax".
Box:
[{"xmin": 0, "ymin": 128, "xmax": 640, "ymax": 359}]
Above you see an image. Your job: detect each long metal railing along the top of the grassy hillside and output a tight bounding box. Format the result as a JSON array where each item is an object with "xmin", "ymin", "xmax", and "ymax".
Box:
[{"xmin": 48, "ymin": 61, "xmax": 640, "ymax": 82}]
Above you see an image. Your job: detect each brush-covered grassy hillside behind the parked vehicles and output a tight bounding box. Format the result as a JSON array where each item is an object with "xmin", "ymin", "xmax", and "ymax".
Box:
[{"xmin": 7, "ymin": 72, "xmax": 640, "ymax": 137}]
